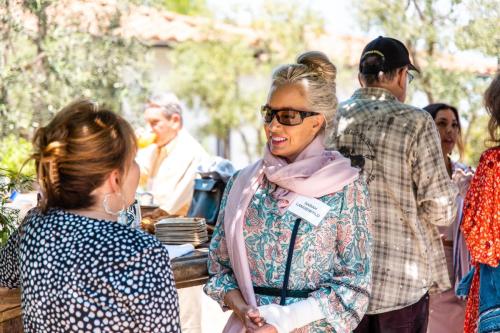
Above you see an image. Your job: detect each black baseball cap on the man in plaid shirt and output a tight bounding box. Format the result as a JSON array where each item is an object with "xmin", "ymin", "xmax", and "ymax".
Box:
[{"xmin": 359, "ymin": 36, "xmax": 420, "ymax": 74}]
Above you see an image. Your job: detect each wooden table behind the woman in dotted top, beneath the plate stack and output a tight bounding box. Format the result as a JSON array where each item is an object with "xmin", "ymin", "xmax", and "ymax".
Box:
[{"xmin": 0, "ymin": 245, "xmax": 208, "ymax": 333}]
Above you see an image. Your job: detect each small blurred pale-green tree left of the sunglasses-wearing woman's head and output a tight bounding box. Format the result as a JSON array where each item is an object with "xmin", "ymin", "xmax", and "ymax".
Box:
[{"xmin": 172, "ymin": 41, "xmax": 256, "ymax": 156}]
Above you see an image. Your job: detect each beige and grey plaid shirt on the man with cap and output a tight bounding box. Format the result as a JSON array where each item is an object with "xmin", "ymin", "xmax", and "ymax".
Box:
[{"xmin": 327, "ymin": 88, "xmax": 458, "ymax": 314}]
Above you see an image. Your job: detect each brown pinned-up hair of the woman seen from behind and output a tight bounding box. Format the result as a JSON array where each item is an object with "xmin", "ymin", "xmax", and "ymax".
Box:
[{"xmin": 32, "ymin": 100, "xmax": 137, "ymax": 212}]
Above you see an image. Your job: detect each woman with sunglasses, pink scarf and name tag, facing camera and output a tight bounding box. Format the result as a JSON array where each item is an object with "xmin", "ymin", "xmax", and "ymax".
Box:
[{"xmin": 205, "ymin": 52, "xmax": 371, "ymax": 333}]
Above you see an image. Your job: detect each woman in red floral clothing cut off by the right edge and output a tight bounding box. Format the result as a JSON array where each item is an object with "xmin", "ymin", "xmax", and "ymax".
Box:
[{"xmin": 459, "ymin": 73, "xmax": 500, "ymax": 333}]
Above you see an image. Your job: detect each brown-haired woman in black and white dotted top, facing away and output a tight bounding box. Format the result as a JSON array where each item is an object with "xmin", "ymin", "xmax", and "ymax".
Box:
[{"xmin": 0, "ymin": 100, "xmax": 180, "ymax": 333}]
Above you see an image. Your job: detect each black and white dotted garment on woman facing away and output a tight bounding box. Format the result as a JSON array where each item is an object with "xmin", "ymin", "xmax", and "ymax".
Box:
[{"xmin": 0, "ymin": 209, "xmax": 180, "ymax": 333}]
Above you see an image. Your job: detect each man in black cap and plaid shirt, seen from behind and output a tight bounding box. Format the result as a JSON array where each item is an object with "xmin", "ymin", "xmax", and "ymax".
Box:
[{"xmin": 327, "ymin": 36, "xmax": 457, "ymax": 333}]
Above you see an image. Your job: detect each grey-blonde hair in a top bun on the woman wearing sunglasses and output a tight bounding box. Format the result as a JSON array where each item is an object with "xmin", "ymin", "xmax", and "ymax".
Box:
[{"xmin": 271, "ymin": 51, "xmax": 337, "ymax": 127}]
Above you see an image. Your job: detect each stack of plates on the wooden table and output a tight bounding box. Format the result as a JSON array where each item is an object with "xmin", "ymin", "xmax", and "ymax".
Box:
[{"xmin": 155, "ymin": 217, "xmax": 208, "ymax": 246}]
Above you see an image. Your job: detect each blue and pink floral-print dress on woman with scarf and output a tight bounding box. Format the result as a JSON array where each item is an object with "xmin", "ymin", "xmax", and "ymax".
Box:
[{"xmin": 204, "ymin": 177, "xmax": 372, "ymax": 333}]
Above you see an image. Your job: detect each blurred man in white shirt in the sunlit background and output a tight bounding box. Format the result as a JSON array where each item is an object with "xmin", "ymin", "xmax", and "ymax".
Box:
[{"xmin": 137, "ymin": 93, "xmax": 208, "ymax": 216}]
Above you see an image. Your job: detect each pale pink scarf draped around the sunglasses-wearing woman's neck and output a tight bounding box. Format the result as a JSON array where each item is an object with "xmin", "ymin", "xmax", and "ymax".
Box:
[{"xmin": 223, "ymin": 136, "xmax": 359, "ymax": 333}]
